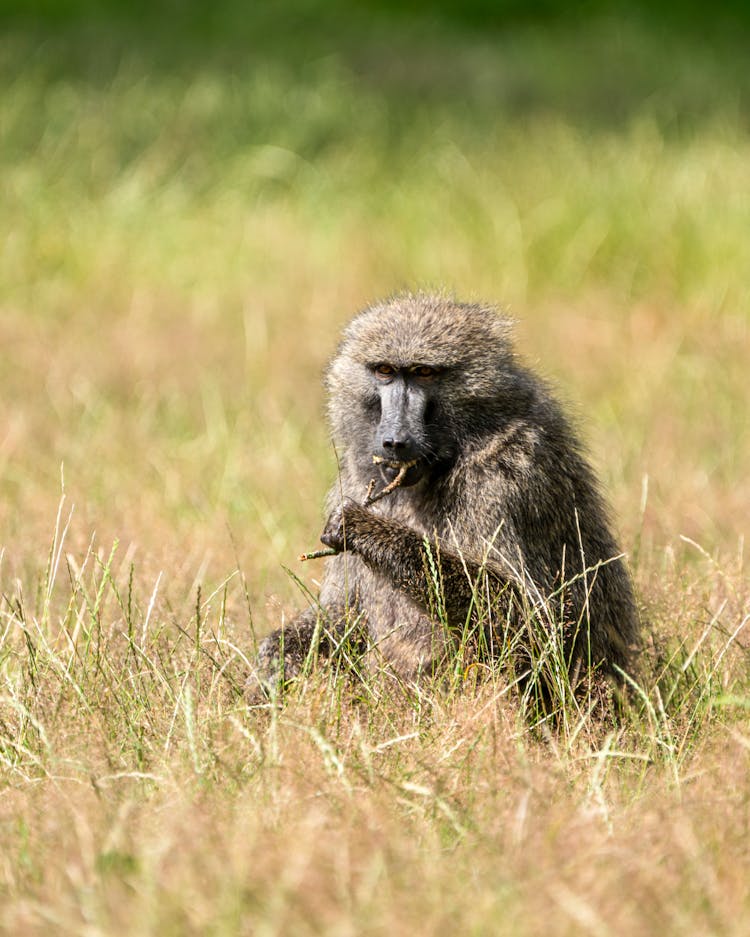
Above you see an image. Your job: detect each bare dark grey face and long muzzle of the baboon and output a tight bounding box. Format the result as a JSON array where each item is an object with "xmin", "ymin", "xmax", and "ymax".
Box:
[{"xmin": 368, "ymin": 361, "xmax": 444, "ymax": 486}]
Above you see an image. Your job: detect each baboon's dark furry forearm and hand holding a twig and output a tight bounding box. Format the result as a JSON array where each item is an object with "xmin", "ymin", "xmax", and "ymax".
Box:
[{"xmin": 321, "ymin": 498, "xmax": 517, "ymax": 622}]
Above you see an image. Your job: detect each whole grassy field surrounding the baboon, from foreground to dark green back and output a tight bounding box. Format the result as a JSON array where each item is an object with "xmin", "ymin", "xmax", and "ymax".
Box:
[{"xmin": 0, "ymin": 3, "xmax": 750, "ymax": 937}]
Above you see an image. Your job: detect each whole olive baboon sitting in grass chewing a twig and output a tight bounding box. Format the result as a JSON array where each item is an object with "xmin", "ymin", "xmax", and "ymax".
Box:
[{"xmin": 258, "ymin": 294, "xmax": 638, "ymax": 696}]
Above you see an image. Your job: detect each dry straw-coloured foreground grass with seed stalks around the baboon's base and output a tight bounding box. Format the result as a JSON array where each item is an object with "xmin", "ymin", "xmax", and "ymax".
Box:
[{"xmin": 0, "ymin": 494, "xmax": 748, "ymax": 934}]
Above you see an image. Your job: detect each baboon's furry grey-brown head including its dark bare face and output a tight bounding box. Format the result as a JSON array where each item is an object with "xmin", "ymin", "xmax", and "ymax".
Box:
[{"xmin": 328, "ymin": 294, "xmax": 513, "ymax": 485}]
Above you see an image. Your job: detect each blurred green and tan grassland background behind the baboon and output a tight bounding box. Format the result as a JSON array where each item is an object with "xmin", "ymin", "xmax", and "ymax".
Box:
[{"xmin": 0, "ymin": 0, "xmax": 750, "ymax": 608}]
